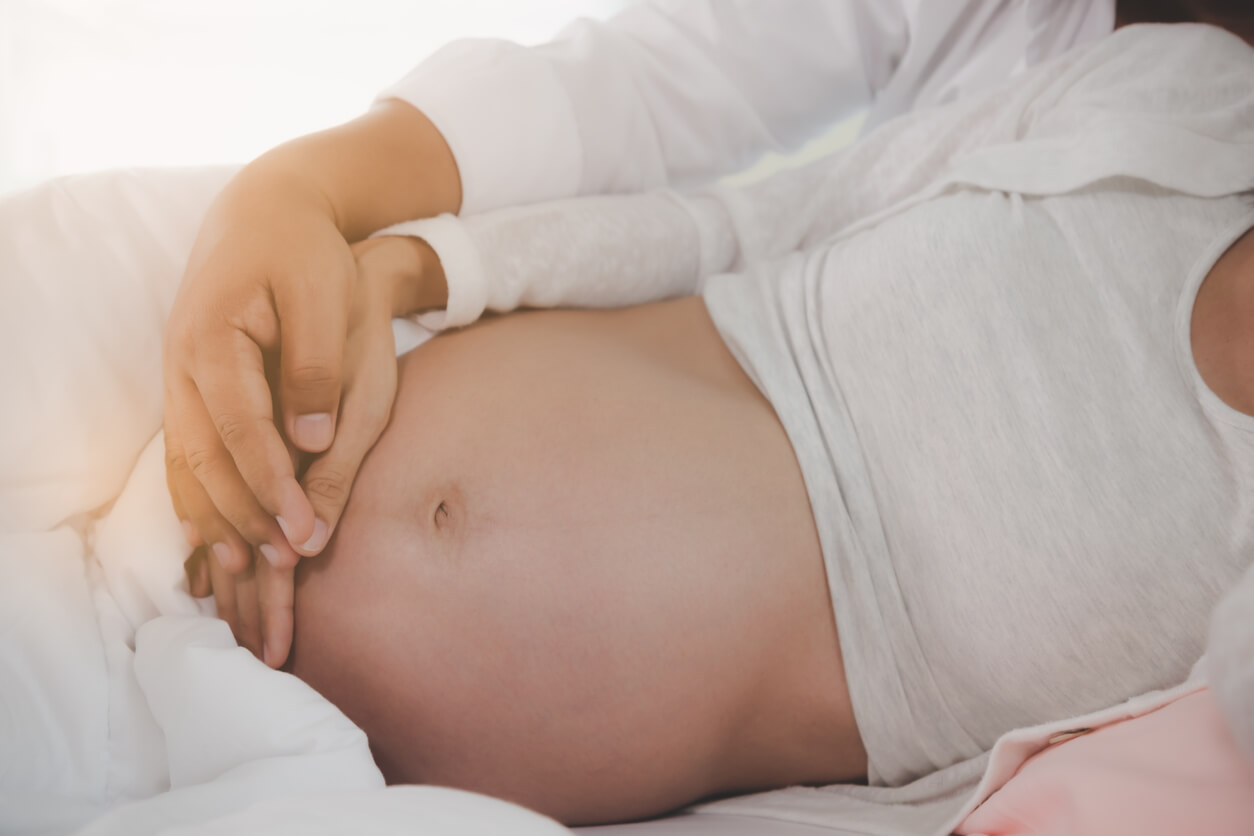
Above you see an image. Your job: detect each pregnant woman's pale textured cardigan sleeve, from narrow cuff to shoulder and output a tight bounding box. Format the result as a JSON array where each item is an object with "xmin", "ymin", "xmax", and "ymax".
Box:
[{"xmin": 377, "ymin": 26, "xmax": 1254, "ymax": 327}]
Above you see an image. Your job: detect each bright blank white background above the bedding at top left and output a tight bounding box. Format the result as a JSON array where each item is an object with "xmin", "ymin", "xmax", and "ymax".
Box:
[{"xmin": 0, "ymin": 0, "xmax": 630, "ymax": 193}]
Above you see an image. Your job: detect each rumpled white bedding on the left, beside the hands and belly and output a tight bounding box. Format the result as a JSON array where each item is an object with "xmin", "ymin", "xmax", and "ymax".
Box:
[{"xmin": 0, "ymin": 168, "xmax": 882, "ymax": 836}]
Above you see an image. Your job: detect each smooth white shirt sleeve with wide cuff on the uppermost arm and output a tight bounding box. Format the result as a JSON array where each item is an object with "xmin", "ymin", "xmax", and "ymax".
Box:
[{"xmin": 380, "ymin": 0, "xmax": 908, "ymax": 214}]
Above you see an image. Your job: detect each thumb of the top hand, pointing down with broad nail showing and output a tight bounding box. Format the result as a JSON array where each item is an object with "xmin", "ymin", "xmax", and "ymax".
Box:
[{"xmin": 275, "ymin": 258, "xmax": 354, "ymax": 452}]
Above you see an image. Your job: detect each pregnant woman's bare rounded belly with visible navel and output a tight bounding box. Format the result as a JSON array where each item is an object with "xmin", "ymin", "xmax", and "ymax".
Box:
[{"xmin": 290, "ymin": 298, "xmax": 865, "ymax": 823}]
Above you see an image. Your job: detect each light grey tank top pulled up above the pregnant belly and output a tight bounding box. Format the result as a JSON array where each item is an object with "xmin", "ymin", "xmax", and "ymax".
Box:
[{"xmin": 705, "ymin": 180, "xmax": 1254, "ymax": 785}]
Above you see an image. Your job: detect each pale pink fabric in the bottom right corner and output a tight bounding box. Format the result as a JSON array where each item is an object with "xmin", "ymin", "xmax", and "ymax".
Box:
[{"xmin": 956, "ymin": 688, "xmax": 1254, "ymax": 836}]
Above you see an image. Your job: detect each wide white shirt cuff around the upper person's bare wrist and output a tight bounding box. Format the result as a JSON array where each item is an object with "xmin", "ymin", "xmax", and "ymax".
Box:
[{"xmin": 379, "ymin": 40, "xmax": 583, "ymax": 214}]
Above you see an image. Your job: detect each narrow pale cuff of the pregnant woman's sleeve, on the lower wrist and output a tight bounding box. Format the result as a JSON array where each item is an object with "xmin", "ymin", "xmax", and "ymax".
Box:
[{"xmin": 371, "ymin": 214, "xmax": 488, "ymax": 331}]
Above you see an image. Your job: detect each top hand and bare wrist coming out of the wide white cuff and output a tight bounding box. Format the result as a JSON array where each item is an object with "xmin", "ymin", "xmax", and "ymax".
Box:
[{"xmin": 164, "ymin": 103, "xmax": 460, "ymax": 569}]
